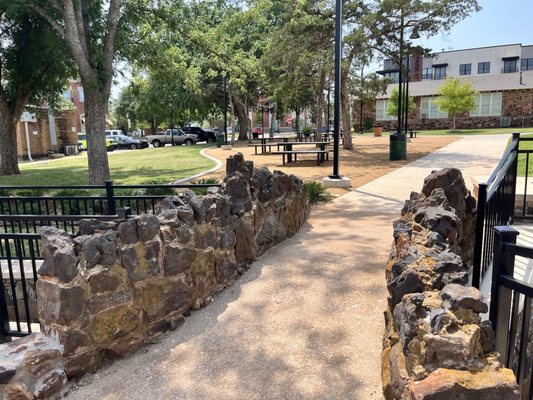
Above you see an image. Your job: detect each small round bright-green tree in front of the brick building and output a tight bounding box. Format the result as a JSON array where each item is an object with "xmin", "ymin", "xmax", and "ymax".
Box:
[{"xmin": 436, "ymin": 78, "xmax": 478, "ymax": 130}]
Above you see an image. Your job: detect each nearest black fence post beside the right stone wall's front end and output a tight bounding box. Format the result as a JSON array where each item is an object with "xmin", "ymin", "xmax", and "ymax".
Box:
[{"xmin": 489, "ymin": 226, "xmax": 518, "ymax": 365}]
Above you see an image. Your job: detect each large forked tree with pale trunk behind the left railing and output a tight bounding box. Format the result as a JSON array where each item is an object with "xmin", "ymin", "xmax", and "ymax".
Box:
[{"xmin": 18, "ymin": 0, "xmax": 145, "ymax": 184}]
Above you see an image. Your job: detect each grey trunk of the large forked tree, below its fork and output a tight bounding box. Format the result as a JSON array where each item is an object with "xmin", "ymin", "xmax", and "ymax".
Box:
[{"xmin": 82, "ymin": 87, "xmax": 111, "ymax": 185}]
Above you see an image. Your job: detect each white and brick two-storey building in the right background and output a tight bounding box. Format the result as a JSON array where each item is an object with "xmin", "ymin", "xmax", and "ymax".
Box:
[{"xmin": 374, "ymin": 44, "xmax": 533, "ymax": 130}]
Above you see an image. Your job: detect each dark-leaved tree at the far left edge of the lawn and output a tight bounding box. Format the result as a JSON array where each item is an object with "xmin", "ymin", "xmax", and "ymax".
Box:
[{"xmin": 0, "ymin": 2, "xmax": 75, "ymax": 175}]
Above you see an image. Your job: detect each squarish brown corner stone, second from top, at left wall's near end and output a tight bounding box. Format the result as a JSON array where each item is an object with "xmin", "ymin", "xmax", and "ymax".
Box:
[{"xmin": 36, "ymin": 279, "xmax": 86, "ymax": 325}]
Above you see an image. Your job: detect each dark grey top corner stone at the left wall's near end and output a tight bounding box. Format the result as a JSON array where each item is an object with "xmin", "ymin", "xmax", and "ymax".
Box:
[{"xmin": 38, "ymin": 227, "xmax": 78, "ymax": 283}]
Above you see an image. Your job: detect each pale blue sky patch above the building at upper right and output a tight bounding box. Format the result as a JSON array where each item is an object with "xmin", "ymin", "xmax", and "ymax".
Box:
[{"xmin": 420, "ymin": 0, "xmax": 533, "ymax": 52}]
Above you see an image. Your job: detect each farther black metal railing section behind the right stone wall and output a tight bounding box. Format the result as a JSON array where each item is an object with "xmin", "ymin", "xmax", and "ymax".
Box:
[{"xmin": 472, "ymin": 133, "xmax": 520, "ymax": 288}]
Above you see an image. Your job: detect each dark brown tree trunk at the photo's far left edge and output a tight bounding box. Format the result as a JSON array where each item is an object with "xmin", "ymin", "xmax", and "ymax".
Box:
[{"xmin": 0, "ymin": 99, "xmax": 20, "ymax": 176}]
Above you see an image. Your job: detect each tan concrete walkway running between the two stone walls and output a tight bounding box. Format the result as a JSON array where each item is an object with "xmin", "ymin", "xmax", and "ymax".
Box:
[{"xmin": 69, "ymin": 135, "xmax": 508, "ymax": 400}]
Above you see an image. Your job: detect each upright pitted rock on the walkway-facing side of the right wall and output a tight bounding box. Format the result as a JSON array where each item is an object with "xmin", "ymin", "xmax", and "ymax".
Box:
[{"xmin": 394, "ymin": 293, "xmax": 427, "ymax": 350}]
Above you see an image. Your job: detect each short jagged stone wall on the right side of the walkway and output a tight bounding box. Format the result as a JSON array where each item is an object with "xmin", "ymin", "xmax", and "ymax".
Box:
[{"xmin": 382, "ymin": 169, "xmax": 519, "ymax": 400}]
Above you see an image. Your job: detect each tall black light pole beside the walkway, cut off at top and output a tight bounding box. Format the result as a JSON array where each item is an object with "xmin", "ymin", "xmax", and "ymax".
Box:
[{"xmin": 329, "ymin": 0, "xmax": 340, "ymax": 179}]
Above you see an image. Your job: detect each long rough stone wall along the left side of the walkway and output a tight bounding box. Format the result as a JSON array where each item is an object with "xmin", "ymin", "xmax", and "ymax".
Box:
[{"xmin": 37, "ymin": 154, "xmax": 309, "ymax": 377}]
